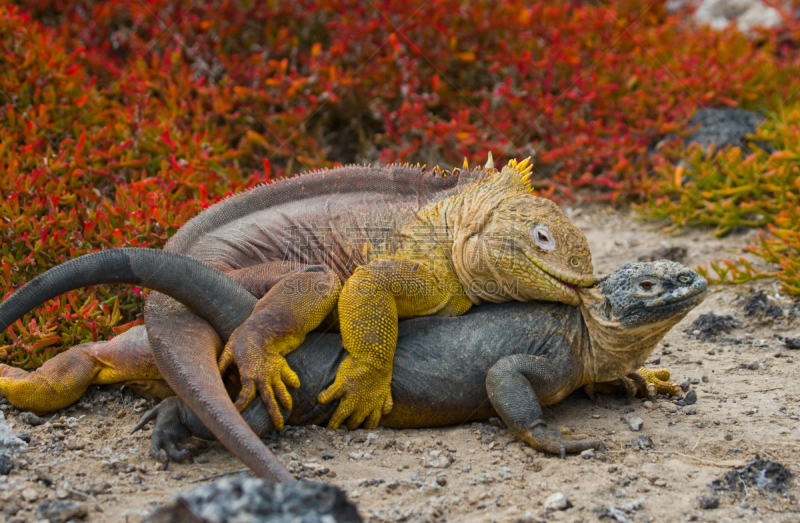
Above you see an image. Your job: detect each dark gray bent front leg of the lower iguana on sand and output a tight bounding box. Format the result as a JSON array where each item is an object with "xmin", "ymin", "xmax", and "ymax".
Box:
[{"xmin": 486, "ymin": 354, "xmax": 604, "ymax": 457}]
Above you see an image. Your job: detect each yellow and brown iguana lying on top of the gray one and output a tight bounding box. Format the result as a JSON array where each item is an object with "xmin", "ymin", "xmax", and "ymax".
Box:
[{"xmin": 0, "ymin": 157, "xmax": 594, "ymax": 484}]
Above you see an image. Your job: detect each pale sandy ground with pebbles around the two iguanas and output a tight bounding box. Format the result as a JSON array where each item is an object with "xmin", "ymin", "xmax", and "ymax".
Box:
[{"xmin": 0, "ymin": 208, "xmax": 800, "ymax": 523}]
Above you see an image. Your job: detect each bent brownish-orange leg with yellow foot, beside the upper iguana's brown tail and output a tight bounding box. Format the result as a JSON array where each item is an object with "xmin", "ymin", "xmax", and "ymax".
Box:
[{"xmin": 219, "ymin": 265, "xmax": 342, "ymax": 429}]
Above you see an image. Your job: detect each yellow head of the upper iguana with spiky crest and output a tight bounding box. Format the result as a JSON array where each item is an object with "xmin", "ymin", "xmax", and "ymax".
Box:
[{"xmin": 453, "ymin": 156, "xmax": 595, "ymax": 305}]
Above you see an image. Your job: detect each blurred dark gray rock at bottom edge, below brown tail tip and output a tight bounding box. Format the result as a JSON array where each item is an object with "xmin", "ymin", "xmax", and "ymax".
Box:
[{"xmin": 146, "ymin": 476, "xmax": 362, "ymax": 523}]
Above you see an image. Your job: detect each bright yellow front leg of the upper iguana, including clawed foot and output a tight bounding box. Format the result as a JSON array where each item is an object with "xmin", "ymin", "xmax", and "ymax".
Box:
[{"xmin": 317, "ymin": 259, "xmax": 472, "ymax": 430}]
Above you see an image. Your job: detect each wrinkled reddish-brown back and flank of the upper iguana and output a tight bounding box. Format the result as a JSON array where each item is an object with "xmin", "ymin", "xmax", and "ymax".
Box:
[{"xmin": 164, "ymin": 165, "xmax": 459, "ymax": 280}]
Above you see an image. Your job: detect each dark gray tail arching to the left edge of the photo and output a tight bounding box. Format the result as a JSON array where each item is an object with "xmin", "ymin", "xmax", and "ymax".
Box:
[{"xmin": 0, "ymin": 248, "xmax": 257, "ymax": 340}]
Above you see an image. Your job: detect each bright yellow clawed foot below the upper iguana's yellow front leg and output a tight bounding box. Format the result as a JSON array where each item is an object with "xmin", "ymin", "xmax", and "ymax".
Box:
[{"xmin": 317, "ymin": 356, "xmax": 393, "ymax": 430}]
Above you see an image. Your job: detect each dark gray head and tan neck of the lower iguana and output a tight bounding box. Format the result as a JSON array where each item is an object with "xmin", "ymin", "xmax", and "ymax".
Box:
[{"xmin": 579, "ymin": 260, "xmax": 708, "ymax": 382}]
